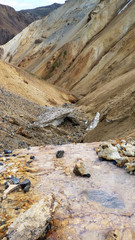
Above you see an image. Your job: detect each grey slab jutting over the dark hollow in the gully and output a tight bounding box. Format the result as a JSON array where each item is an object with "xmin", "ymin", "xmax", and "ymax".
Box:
[{"xmin": 34, "ymin": 106, "xmax": 73, "ymax": 127}]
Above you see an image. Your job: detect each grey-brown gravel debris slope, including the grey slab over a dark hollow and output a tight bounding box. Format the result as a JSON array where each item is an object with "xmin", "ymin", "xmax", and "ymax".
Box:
[{"xmin": 0, "ymin": 89, "xmax": 88, "ymax": 151}]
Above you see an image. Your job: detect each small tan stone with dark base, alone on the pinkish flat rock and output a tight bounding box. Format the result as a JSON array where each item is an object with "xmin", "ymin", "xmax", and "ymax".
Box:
[{"xmin": 73, "ymin": 161, "xmax": 91, "ymax": 178}]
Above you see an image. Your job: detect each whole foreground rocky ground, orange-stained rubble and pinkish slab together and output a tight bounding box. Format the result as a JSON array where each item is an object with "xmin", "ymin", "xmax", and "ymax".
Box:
[{"xmin": 0, "ymin": 143, "xmax": 135, "ymax": 240}]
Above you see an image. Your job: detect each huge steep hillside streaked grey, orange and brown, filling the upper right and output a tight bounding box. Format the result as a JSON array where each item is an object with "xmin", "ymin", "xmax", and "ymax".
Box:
[{"xmin": 1, "ymin": 0, "xmax": 135, "ymax": 142}]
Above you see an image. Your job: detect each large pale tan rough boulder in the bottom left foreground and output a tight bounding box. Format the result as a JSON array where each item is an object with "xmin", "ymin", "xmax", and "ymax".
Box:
[{"xmin": 8, "ymin": 195, "xmax": 54, "ymax": 240}]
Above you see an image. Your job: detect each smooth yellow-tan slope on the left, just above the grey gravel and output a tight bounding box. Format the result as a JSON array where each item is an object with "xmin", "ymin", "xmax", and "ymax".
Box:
[{"xmin": 0, "ymin": 60, "xmax": 74, "ymax": 106}]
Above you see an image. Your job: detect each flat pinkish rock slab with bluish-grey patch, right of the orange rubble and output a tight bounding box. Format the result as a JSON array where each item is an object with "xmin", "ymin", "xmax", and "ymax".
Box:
[{"xmin": 3, "ymin": 143, "xmax": 135, "ymax": 240}]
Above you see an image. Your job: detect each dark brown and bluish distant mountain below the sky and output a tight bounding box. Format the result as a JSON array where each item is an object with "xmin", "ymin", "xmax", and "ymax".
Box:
[{"xmin": 0, "ymin": 3, "xmax": 61, "ymax": 44}]
